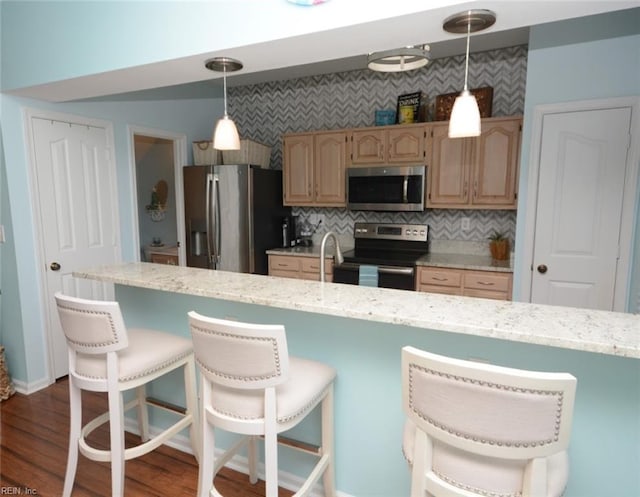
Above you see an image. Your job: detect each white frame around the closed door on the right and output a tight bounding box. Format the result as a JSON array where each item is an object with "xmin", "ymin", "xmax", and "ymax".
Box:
[{"xmin": 520, "ymin": 97, "xmax": 640, "ymax": 312}]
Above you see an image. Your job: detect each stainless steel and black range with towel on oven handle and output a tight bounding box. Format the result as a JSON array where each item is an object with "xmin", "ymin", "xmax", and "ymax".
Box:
[{"xmin": 333, "ymin": 223, "xmax": 429, "ymax": 290}]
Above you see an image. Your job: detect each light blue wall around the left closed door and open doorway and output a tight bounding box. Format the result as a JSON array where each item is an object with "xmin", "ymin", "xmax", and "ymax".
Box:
[{"xmin": 0, "ymin": 96, "xmax": 223, "ymax": 386}]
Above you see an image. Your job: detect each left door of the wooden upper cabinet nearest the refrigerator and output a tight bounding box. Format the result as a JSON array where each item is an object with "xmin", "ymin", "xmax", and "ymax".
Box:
[{"xmin": 282, "ymin": 134, "xmax": 313, "ymax": 205}]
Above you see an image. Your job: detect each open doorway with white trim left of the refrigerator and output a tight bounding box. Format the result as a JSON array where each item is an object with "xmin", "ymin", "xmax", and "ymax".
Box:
[{"xmin": 130, "ymin": 127, "xmax": 186, "ymax": 265}]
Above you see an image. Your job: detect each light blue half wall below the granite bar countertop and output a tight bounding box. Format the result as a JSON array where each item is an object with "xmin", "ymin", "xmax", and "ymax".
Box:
[{"xmin": 116, "ymin": 286, "xmax": 640, "ymax": 497}]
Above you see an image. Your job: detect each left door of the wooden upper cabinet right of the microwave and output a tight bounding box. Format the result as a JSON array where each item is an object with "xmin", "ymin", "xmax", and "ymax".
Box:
[{"xmin": 427, "ymin": 122, "xmax": 474, "ymax": 207}]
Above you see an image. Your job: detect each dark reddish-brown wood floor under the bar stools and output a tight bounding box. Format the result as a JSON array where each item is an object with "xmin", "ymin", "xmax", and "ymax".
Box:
[{"xmin": 0, "ymin": 379, "xmax": 292, "ymax": 497}]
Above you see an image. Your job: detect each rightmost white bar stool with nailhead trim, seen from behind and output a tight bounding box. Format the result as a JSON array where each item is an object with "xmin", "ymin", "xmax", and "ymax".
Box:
[{"xmin": 402, "ymin": 347, "xmax": 576, "ymax": 497}]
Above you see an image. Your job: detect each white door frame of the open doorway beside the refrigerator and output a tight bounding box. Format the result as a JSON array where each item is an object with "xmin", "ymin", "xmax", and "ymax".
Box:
[{"xmin": 127, "ymin": 125, "xmax": 187, "ymax": 266}]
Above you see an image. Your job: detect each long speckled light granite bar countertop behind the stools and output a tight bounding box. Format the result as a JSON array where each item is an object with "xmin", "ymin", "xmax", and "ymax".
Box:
[{"xmin": 74, "ymin": 262, "xmax": 640, "ymax": 359}]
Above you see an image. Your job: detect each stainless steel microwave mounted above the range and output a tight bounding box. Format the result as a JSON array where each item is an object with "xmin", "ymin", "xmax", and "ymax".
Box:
[{"xmin": 347, "ymin": 166, "xmax": 427, "ymax": 211}]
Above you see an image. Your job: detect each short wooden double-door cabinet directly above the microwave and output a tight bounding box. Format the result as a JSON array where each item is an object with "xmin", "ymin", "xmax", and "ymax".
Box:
[{"xmin": 351, "ymin": 124, "xmax": 426, "ymax": 166}]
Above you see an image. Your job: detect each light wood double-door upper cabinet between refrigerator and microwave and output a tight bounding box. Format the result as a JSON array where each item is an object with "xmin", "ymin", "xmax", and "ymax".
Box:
[{"xmin": 282, "ymin": 131, "xmax": 348, "ymax": 207}]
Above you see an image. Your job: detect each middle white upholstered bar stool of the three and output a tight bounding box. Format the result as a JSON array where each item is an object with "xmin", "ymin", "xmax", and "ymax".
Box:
[{"xmin": 189, "ymin": 311, "xmax": 336, "ymax": 497}]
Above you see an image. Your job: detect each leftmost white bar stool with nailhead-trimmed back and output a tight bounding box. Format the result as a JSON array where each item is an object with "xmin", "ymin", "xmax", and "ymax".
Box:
[{"xmin": 55, "ymin": 293, "xmax": 199, "ymax": 497}]
